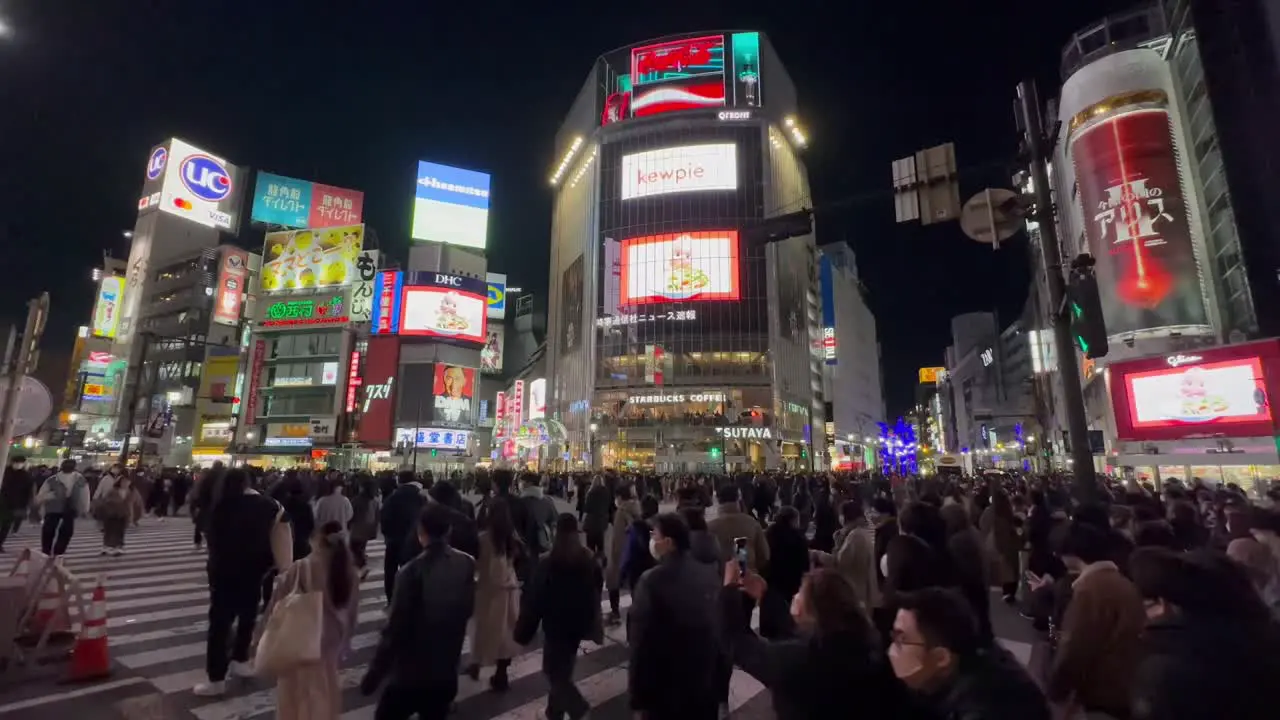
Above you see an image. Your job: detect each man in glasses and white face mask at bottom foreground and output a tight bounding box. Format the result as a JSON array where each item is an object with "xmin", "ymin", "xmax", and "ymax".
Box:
[{"xmin": 888, "ymin": 588, "xmax": 1052, "ymax": 720}]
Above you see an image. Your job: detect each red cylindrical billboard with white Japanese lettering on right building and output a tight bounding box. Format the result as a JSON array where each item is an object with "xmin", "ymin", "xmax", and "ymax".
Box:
[{"xmin": 1069, "ymin": 91, "xmax": 1208, "ymax": 336}]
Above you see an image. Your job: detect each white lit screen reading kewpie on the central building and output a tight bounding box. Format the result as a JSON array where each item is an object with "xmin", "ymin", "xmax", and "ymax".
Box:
[{"xmin": 622, "ymin": 142, "xmax": 737, "ymax": 200}]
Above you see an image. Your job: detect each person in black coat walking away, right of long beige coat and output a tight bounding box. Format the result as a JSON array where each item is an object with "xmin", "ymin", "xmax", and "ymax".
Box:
[{"xmin": 515, "ymin": 512, "xmax": 604, "ymax": 720}]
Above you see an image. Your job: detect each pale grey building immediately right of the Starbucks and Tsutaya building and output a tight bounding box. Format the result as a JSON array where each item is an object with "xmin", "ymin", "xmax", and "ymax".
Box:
[{"xmin": 819, "ymin": 242, "xmax": 886, "ymax": 469}]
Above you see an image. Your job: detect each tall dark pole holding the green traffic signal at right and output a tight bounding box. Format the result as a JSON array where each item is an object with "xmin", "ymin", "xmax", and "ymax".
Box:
[{"xmin": 1016, "ymin": 81, "xmax": 1098, "ymax": 501}]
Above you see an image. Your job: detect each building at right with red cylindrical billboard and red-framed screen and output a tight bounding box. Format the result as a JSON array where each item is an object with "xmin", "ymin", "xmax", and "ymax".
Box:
[{"xmin": 1033, "ymin": 0, "xmax": 1280, "ymax": 487}]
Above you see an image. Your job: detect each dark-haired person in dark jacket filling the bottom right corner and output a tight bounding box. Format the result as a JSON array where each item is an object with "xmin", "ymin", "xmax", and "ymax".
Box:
[{"xmin": 1129, "ymin": 547, "xmax": 1280, "ymax": 720}]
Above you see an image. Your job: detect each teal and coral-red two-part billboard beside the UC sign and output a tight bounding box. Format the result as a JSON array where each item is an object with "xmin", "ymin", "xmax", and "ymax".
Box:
[{"xmin": 250, "ymin": 172, "xmax": 365, "ymax": 228}]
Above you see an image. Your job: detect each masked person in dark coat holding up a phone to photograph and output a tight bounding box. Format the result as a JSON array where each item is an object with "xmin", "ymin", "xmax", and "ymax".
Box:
[{"xmin": 719, "ymin": 561, "xmax": 923, "ymax": 720}]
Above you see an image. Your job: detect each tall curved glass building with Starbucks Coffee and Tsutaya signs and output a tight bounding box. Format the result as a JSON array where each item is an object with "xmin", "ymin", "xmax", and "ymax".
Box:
[{"xmin": 547, "ymin": 32, "xmax": 826, "ymax": 470}]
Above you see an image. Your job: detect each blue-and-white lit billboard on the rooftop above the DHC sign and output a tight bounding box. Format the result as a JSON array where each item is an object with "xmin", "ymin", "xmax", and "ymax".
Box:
[{"xmin": 410, "ymin": 161, "xmax": 489, "ymax": 250}]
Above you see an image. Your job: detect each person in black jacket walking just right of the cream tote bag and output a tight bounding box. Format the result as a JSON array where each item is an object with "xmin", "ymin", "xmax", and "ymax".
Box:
[{"xmin": 360, "ymin": 502, "xmax": 476, "ymax": 720}]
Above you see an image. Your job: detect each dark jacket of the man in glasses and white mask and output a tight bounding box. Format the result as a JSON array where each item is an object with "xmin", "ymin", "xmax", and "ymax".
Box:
[{"xmin": 925, "ymin": 646, "xmax": 1052, "ymax": 720}]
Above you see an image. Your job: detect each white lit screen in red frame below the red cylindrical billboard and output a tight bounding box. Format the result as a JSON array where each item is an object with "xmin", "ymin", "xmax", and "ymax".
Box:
[{"xmin": 1125, "ymin": 357, "xmax": 1271, "ymax": 429}]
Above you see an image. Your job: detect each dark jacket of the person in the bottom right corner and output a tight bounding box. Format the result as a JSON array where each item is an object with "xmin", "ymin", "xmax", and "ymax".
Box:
[{"xmin": 1133, "ymin": 609, "xmax": 1280, "ymax": 720}]
